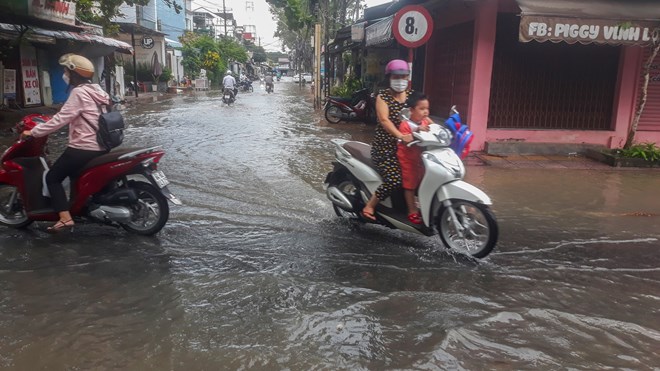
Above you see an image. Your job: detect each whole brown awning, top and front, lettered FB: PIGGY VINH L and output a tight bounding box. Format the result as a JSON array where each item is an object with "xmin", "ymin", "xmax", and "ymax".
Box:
[{"xmin": 516, "ymin": 0, "xmax": 660, "ymax": 45}]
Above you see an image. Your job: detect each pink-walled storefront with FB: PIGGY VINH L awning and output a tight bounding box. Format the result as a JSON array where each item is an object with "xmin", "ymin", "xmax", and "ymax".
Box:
[{"xmin": 424, "ymin": 0, "xmax": 660, "ymax": 150}]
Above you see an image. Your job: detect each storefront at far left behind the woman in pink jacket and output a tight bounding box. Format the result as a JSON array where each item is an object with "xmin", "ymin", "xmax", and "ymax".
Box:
[{"xmin": 0, "ymin": 0, "xmax": 132, "ymax": 108}]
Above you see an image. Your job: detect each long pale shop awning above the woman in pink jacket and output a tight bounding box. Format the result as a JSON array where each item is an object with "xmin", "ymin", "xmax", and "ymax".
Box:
[{"xmin": 0, "ymin": 23, "xmax": 133, "ymax": 54}]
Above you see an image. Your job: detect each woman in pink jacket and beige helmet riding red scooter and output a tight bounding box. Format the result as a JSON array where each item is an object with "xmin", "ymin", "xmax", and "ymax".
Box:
[{"xmin": 22, "ymin": 54, "xmax": 110, "ymax": 233}]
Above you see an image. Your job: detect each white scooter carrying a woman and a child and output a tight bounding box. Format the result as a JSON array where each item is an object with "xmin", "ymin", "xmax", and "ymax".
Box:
[{"xmin": 324, "ymin": 107, "xmax": 498, "ymax": 258}]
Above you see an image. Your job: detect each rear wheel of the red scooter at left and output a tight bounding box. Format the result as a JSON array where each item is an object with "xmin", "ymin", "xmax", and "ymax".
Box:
[{"xmin": 121, "ymin": 182, "xmax": 170, "ymax": 236}]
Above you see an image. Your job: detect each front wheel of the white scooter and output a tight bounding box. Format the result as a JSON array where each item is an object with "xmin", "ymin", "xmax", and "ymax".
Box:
[{"xmin": 437, "ymin": 200, "xmax": 499, "ymax": 258}]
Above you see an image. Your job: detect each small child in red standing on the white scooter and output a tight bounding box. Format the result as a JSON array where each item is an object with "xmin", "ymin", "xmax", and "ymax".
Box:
[{"xmin": 397, "ymin": 92, "xmax": 431, "ymax": 224}]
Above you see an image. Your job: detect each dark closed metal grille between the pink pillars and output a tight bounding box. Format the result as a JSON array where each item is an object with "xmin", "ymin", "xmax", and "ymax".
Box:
[{"xmin": 488, "ymin": 14, "xmax": 621, "ymax": 130}]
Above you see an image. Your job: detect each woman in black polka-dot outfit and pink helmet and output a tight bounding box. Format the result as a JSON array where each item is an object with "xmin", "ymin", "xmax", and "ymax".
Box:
[{"xmin": 362, "ymin": 59, "xmax": 413, "ymax": 220}]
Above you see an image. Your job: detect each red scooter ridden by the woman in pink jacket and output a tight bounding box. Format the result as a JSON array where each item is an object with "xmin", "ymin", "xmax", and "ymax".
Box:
[{"xmin": 0, "ymin": 114, "xmax": 181, "ymax": 235}]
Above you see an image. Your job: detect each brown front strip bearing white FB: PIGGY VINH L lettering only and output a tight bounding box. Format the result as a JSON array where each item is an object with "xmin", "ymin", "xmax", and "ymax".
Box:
[{"xmin": 518, "ymin": 14, "xmax": 660, "ymax": 45}]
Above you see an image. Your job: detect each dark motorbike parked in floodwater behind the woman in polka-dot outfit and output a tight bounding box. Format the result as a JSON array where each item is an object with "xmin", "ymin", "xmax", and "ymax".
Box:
[{"xmin": 323, "ymin": 88, "xmax": 376, "ymax": 124}]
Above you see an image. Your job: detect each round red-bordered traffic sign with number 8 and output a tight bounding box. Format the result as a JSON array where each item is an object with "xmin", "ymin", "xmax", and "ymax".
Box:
[{"xmin": 392, "ymin": 5, "xmax": 433, "ymax": 48}]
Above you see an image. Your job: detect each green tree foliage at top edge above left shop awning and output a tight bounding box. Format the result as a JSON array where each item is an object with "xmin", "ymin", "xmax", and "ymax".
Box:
[{"xmin": 76, "ymin": 0, "xmax": 183, "ymax": 35}]
